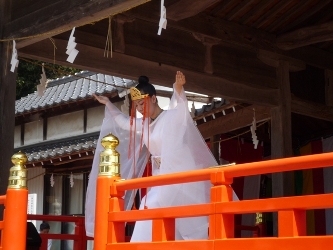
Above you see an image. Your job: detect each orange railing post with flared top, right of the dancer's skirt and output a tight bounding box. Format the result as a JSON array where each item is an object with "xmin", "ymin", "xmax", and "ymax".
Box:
[{"xmin": 209, "ymin": 170, "xmax": 235, "ymax": 240}]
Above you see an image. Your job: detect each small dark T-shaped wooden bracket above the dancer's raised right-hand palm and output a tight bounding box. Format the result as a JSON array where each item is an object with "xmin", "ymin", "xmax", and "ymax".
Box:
[{"xmin": 192, "ymin": 33, "xmax": 221, "ymax": 74}]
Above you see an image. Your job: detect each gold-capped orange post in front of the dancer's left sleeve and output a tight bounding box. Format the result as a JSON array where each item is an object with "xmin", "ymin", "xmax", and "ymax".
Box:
[{"xmin": 94, "ymin": 134, "xmax": 125, "ymax": 250}]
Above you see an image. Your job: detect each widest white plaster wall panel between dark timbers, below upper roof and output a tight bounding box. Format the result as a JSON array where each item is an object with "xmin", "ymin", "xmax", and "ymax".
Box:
[{"xmin": 47, "ymin": 110, "xmax": 83, "ymax": 140}]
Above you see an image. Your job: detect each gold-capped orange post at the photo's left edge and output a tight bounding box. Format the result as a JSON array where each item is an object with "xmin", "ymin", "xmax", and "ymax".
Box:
[{"xmin": 1, "ymin": 152, "xmax": 28, "ymax": 250}]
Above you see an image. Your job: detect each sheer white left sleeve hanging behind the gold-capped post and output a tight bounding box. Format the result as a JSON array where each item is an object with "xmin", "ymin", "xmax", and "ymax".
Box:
[{"xmin": 85, "ymin": 99, "xmax": 147, "ymax": 237}]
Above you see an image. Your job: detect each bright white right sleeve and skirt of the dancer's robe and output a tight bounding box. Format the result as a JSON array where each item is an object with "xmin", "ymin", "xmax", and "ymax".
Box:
[{"xmin": 131, "ymin": 87, "xmax": 217, "ymax": 242}]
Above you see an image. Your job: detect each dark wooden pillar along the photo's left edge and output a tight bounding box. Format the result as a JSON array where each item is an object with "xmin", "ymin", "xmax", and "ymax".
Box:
[{"xmin": 0, "ymin": 0, "xmax": 16, "ymax": 219}]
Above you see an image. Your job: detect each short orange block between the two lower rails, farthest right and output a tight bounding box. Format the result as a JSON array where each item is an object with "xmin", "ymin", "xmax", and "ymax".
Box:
[{"xmin": 278, "ymin": 210, "xmax": 306, "ymax": 237}]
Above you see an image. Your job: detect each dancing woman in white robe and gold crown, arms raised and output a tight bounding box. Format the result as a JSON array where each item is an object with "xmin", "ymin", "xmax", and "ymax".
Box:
[{"xmin": 85, "ymin": 71, "xmax": 237, "ymax": 242}]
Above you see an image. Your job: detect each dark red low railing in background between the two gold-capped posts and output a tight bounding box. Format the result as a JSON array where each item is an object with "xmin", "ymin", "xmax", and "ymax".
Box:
[{"xmin": 28, "ymin": 214, "xmax": 93, "ymax": 250}]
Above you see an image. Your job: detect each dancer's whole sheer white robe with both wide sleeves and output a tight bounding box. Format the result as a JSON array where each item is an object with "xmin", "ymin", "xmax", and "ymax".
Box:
[{"xmin": 86, "ymin": 84, "xmax": 236, "ymax": 241}]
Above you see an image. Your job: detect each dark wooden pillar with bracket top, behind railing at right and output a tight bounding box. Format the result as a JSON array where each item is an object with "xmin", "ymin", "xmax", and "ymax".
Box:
[{"xmin": 257, "ymin": 50, "xmax": 306, "ymax": 236}]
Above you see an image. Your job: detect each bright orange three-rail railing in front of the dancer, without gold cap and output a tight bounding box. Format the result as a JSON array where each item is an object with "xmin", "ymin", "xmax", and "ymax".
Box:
[{"xmin": 94, "ymin": 153, "xmax": 333, "ymax": 250}]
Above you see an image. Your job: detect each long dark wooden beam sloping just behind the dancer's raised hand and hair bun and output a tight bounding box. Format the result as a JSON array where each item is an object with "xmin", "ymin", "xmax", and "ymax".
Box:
[{"xmin": 19, "ymin": 40, "xmax": 278, "ymax": 106}]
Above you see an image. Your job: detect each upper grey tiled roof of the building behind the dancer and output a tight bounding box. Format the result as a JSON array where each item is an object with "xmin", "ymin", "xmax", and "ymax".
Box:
[{"xmin": 15, "ymin": 72, "xmax": 137, "ymax": 115}]
